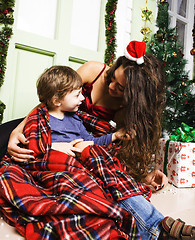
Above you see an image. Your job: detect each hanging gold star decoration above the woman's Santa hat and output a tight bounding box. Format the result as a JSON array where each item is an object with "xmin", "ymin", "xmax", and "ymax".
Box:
[{"xmin": 140, "ymin": 0, "xmax": 152, "ymax": 43}]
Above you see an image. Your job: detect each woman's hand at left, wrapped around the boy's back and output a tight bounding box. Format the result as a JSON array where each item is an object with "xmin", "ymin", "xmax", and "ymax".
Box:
[{"xmin": 7, "ymin": 129, "xmax": 34, "ymax": 162}]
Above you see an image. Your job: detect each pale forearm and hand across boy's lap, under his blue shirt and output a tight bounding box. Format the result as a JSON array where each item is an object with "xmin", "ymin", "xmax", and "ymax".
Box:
[{"xmin": 51, "ymin": 139, "xmax": 83, "ymax": 157}]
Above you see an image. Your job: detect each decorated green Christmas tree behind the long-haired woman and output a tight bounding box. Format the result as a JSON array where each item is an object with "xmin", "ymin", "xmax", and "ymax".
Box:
[{"xmin": 147, "ymin": 0, "xmax": 195, "ymax": 133}]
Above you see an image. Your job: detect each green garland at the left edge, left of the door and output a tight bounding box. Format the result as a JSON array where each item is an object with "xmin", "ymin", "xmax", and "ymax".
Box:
[{"xmin": 0, "ymin": 0, "xmax": 15, "ymax": 123}]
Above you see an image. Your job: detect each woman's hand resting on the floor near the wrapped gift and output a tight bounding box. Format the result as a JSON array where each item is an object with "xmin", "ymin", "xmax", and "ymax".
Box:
[{"xmin": 145, "ymin": 170, "xmax": 168, "ymax": 191}]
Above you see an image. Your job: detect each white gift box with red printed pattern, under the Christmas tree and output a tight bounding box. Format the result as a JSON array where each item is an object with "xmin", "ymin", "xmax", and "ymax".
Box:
[{"xmin": 156, "ymin": 138, "xmax": 195, "ymax": 187}]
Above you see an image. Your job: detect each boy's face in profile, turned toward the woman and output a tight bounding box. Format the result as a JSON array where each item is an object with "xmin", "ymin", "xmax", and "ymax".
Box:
[{"xmin": 59, "ymin": 88, "xmax": 85, "ymax": 112}]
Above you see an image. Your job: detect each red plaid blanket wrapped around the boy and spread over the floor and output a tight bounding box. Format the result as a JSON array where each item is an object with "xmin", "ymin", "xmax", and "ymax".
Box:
[{"xmin": 0, "ymin": 106, "xmax": 151, "ymax": 240}]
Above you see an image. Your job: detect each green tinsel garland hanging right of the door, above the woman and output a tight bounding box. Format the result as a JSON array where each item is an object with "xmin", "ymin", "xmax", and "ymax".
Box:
[{"xmin": 104, "ymin": 0, "xmax": 118, "ymax": 66}]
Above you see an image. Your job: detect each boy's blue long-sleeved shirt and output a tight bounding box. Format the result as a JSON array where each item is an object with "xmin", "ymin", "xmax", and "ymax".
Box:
[{"xmin": 49, "ymin": 112, "xmax": 112, "ymax": 146}]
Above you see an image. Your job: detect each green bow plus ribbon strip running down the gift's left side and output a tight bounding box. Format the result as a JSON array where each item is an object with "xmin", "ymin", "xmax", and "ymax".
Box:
[{"xmin": 163, "ymin": 122, "xmax": 195, "ymax": 175}]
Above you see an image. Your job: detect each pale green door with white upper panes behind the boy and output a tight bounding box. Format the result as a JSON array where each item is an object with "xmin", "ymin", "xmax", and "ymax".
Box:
[{"xmin": 0, "ymin": 0, "xmax": 106, "ymax": 122}]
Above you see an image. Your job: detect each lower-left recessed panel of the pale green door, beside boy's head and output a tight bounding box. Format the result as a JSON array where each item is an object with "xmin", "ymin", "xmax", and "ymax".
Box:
[{"xmin": 13, "ymin": 45, "xmax": 54, "ymax": 118}]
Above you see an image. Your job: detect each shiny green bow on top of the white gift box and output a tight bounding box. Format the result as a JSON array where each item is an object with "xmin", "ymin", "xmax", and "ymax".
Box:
[{"xmin": 169, "ymin": 122, "xmax": 195, "ymax": 142}]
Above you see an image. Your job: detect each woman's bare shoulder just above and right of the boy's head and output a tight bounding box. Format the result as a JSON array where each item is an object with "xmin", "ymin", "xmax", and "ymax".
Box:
[{"xmin": 77, "ymin": 61, "xmax": 104, "ymax": 83}]
